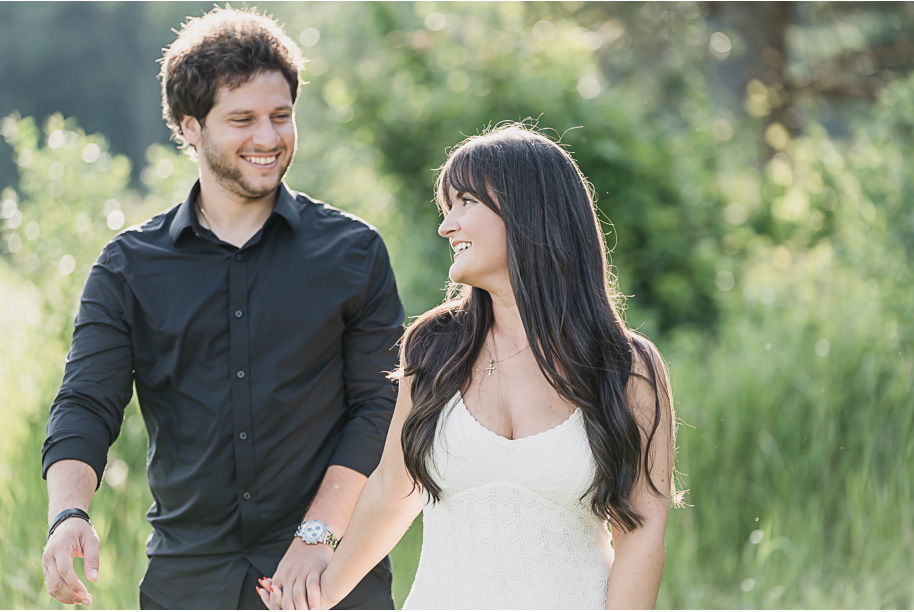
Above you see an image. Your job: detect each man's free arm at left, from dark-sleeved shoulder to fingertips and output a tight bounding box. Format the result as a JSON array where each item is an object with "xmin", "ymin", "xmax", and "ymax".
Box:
[{"xmin": 42, "ymin": 244, "xmax": 133, "ymax": 605}]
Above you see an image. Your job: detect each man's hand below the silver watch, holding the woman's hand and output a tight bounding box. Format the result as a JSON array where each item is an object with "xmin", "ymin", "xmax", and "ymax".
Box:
[{"xmin": 269, "ymin": 538, "xmax": 333, "ymax": 610}]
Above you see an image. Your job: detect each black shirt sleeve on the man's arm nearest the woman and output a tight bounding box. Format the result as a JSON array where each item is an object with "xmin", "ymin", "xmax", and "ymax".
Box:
[{"xmin": 330, "ymin": 232, "xmax": 403, "ymax": 476}]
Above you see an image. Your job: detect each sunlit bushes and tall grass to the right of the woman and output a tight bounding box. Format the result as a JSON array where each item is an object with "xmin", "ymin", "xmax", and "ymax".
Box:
[{"xmin": 661, "ymin": 71, "xmax": 914, "ymax": 608}]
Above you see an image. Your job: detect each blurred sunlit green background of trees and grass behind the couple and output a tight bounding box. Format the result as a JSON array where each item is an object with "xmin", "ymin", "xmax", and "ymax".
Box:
[{"xmin": 0, "ymin": 2, "xmax": 914, "ymax": 609}]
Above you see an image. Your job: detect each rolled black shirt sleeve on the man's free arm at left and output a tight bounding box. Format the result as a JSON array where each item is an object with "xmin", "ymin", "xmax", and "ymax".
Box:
[{"xmin": 42, "ymin": 243, "xmax": 133, "ymax": 485}]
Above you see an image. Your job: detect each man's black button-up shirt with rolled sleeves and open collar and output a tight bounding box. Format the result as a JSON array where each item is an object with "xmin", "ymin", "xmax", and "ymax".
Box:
[{"xmin": 43, "ymin": 184, "xmax": 403, "ymax": 608}]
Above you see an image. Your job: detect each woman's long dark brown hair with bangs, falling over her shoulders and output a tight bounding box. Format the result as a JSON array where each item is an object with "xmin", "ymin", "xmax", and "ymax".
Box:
[{"xmin": 400, "ymin": 124, "xmax": 673, "ymax": 530}]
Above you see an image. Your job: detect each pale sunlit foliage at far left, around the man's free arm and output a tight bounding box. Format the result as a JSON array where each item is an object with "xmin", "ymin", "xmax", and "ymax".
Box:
[{"xmin": 0, "ymin": 116, "xmax": 160, "ymax": 608}]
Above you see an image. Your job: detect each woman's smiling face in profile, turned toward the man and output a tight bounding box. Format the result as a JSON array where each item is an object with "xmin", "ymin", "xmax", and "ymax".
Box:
[{"xmin": 438, "ymin": 185, "xmax": 511, "ymax": 294}]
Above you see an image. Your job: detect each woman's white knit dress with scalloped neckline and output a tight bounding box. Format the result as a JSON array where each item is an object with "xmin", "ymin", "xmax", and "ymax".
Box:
[{"xmin": 403, "ymin": 394, "xmax": 613, "ymax": 610}]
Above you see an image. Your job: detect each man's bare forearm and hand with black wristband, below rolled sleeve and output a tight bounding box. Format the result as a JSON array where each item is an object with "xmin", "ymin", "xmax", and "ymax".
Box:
[{"xmin": 41, "ymin": 460, "xmax": 99, "ymax": 605}]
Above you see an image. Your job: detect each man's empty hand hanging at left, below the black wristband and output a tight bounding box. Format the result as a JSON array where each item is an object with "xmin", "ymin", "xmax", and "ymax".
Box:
[{"xmin": 41, "ymin": 517, "xmax": 99, "ymax": 606}]
